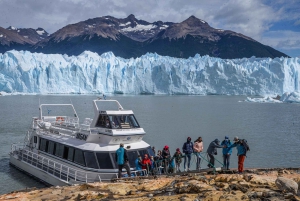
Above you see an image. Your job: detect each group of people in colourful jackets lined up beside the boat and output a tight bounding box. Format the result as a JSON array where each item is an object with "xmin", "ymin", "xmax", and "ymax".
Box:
[{"xmin": 116, "ymin": 136, "xmax": 249, "ymax": 178}]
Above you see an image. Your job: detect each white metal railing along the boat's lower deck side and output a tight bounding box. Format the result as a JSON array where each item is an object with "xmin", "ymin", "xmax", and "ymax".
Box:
[{"xmin": 10, "ymin": 143, "xmax": 118, "ymax": 184}]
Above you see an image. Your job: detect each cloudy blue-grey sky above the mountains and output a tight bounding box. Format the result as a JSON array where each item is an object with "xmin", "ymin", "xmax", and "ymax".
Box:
[{"xmin": 0, "ymin": 0, "xmax": 300, "ymax": 57}]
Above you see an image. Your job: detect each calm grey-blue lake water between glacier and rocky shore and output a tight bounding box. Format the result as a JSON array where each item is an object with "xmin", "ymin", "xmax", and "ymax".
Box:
[{"xmin": 0, "ymin": 95, "xmax": 300, "ymax": 194}]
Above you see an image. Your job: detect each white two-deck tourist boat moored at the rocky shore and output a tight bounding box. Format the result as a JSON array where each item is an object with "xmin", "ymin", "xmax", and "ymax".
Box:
[{"xmin": 10, "ymin": 99, "xmax": 153, "ymax": 186}]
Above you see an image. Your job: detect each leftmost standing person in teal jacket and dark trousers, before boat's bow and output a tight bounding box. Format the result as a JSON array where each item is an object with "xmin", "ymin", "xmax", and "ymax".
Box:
[{"xmin": 116, "ymin": 143, "xmax": 131, "ymax": 178}]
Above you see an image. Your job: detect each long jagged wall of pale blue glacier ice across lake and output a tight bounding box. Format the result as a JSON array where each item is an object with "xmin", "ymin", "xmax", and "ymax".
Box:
[{"xmin": 0, "ymin": 50, "xmax": 300, "ymax": 96}]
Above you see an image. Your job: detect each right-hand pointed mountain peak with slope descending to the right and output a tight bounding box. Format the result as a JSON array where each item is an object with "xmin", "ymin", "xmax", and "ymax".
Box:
[{"xmin": 144, "ymin": 16, "xmax": 287, "ymax": 59}]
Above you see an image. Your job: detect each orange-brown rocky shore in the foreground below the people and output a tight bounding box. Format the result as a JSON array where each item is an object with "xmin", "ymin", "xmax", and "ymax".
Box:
[{"xmin": 0, "ymin": 168, "xmax": 300, "ymax": 201}]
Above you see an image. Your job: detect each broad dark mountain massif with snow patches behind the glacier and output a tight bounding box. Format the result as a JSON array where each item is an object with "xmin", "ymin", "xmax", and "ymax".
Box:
[{"xmin": 0, "ymin": 15, "xmax": 287, "ymax": 59}]
